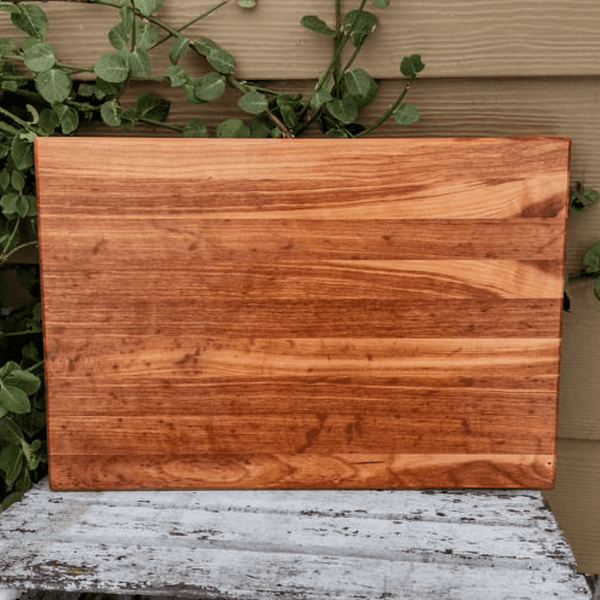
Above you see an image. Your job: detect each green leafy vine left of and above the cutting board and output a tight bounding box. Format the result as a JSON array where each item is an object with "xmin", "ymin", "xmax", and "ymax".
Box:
[{"xmin": 0, "ymin": 0, "xmax": 424, "ymax": 508}]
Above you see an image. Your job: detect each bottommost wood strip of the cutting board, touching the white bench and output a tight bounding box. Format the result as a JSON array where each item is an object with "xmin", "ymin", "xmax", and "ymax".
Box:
[{"xmin": 50, "ymin": 453, "xmax": 556, "ymax": 491}]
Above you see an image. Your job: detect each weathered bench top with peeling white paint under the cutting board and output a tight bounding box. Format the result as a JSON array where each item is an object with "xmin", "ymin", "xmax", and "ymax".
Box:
[{"xmin": 0, "ymin": 481, "xmax": 590, "ymax": 600}]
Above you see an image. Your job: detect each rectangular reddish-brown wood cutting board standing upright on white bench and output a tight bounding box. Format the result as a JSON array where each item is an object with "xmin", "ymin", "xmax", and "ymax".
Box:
[{"xmin": 35, "ymin": 137, "xmax": 570, "ymax": 489}]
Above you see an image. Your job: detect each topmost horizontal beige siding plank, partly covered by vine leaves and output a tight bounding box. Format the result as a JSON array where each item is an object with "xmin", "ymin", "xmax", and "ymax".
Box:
[{"xmin": 0, "ymin": 0, "xmax": 600, "ymax": 79}]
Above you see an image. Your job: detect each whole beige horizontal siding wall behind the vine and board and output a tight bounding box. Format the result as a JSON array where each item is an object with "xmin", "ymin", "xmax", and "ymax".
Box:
[{"xmin": 0, "ymin": 0, "xmax": 600, "ymax": 573}]
